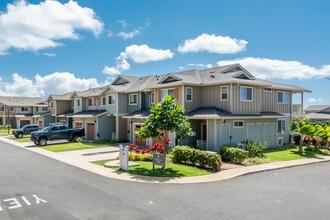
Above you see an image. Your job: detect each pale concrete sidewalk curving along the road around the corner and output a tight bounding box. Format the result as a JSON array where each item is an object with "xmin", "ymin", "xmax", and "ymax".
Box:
[{"xmin": 0, "ymin": 137, "xmax": 330, "ymax": 184}]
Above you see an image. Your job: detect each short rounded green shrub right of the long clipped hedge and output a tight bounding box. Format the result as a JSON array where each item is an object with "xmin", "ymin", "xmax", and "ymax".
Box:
[{"xmin": 220, "ymin": 145, "xmax": 249, "ymax": 163}]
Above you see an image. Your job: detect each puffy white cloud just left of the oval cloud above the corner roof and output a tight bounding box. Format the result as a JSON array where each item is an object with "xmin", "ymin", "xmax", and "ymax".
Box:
[{"xmin": 125, "ymin": 44, "xmax": 174, "ymax": 63}]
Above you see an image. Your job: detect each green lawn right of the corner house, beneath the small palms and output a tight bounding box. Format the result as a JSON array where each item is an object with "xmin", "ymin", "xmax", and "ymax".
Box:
[{"xmin": 265, "ymin": 145, "xmax": 329, "ymax": 162}]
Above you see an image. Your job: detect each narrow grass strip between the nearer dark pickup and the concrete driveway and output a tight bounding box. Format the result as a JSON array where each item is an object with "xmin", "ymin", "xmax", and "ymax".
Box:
[{"xmin": 41, "ymin": 142, "xmax": 116, "ymax": 152}]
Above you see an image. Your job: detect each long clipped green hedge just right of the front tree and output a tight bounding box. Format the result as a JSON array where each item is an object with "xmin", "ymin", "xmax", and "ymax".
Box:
[{"xmin": 172, "ymin": 146, "xmax": 222, "ymax": 171}]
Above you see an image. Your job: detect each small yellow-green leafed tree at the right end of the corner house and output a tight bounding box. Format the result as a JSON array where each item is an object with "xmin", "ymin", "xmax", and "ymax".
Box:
[{"xmin": 290, "ymin": 120, "xmax": 315, "ymax": 153}]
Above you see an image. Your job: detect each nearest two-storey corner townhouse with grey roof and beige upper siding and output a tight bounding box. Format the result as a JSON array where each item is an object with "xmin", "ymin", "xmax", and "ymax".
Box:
[{"xmin": 123, "ymin": 64, "xmax": 310, "ymax": 151}]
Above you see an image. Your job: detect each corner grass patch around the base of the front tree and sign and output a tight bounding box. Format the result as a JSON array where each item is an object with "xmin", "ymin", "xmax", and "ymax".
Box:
[{"xmin": 94, "ymin": 161, "xmax": 213, "ymax": 177}]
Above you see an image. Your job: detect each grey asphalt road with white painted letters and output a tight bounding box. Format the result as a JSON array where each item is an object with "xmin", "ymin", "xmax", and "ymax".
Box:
[{"xmin": 0, "ymin": 141, "xmax": 330, "ymax": 220}]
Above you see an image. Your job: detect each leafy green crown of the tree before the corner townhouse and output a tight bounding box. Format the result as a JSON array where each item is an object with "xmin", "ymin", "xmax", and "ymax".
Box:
[{"xmin": 135, "ymin": 96, "xmax": 195, "ymax": 143}]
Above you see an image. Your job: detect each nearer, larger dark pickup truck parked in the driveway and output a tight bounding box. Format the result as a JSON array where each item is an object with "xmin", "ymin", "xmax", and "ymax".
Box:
[{"xmin": 31, "ymin": 125, "xmax": 85, "ymax": 146}]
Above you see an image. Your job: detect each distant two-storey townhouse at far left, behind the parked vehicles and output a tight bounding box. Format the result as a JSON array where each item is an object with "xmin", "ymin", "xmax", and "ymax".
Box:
[{"xmin": 0, "ymin": 96, "xmax": 52, "ymax": 128}]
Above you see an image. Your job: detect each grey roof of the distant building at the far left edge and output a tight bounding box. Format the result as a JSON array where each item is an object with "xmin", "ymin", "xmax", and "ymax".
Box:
[{"xmin": 0, "ymin": 96, "xmax": 47, "ymax": 106}]
